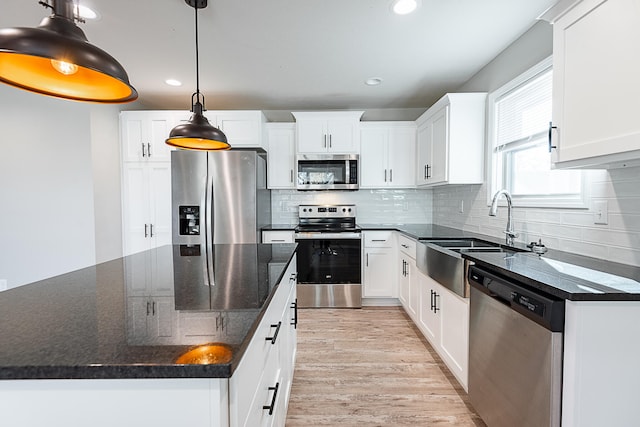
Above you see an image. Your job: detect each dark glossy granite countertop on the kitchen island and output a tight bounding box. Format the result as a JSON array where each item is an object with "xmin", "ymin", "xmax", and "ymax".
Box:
[{"xmin": 0, "ymin": 244, "xmax": 296, "ymax": 379}]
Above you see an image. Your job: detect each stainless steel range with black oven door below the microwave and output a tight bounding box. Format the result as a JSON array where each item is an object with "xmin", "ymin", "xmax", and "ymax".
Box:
[{"xmin": 295, "ymin": 205, "xmax": 362, "ymax": 308}]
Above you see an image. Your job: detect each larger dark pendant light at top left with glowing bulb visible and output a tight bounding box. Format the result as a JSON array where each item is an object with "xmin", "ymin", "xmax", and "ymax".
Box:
[{"xmin": 0, "ymin": 0, "xmax": 138, "ymax": 103}]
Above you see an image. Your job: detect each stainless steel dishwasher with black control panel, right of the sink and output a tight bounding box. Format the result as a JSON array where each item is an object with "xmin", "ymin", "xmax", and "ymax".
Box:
[{"xmin": 468, "ymin": 266, "xmax": 564, "ymax": 427}]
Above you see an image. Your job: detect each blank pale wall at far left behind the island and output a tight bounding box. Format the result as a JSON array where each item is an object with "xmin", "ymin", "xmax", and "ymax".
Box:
[{"xmin": 0, "ymin": 85, "xmax": 120, "ymax": 288}]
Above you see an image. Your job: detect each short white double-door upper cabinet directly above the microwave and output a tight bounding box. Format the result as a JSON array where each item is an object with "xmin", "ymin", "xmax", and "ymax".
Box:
[{"xmin": 292, "ymin": 111, "xmax": 363, "ymax": 154}]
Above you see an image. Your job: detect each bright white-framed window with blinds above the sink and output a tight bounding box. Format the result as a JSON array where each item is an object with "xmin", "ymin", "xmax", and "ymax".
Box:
[{"xmin": 488, "ymin": 58, "xmax": 585, "ymax": 207}]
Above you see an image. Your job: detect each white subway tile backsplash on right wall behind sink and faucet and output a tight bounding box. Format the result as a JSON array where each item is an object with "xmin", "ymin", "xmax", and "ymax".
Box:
[{"xmin": 432, "ymin": 167, "xmax": 640, "ymax": 266}]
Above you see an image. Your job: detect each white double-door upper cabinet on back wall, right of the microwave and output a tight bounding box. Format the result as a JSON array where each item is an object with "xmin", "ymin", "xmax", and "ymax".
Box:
[{"xmin": 360, "ymin": 122, "xmax": 416, "ymax": 188}]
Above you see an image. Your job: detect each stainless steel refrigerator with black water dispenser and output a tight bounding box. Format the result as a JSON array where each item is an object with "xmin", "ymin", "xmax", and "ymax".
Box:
[{"xmin": 171, "ymin": 150, "xmax": 271, "ymax": 245}]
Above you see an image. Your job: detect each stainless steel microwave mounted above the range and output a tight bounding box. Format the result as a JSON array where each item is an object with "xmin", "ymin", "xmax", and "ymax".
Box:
[{"xmin": 296, "ymin": 154, "xmax": 358, "ymax": 190}]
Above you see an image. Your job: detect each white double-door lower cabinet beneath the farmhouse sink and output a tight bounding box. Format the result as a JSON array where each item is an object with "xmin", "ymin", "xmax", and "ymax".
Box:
[{"xmin": 417, "ymin": 272, "xmax": 469, "ymax": 391}]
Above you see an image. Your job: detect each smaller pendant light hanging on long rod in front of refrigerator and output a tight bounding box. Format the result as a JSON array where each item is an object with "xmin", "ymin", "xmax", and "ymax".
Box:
[{"xmin": 165, "ymin": 0, "xmax": 231, "ymax": 151}]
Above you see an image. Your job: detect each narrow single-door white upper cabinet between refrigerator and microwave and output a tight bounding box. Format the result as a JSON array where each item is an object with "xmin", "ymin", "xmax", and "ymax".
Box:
[{"xmin": 267, "ymin": 123, "xmax": 296, "ymax": 189}]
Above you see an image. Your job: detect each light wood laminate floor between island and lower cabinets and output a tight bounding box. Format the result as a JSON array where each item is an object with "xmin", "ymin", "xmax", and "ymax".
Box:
[{"xmin": 286, "ymin": 307, "xmax": 485, "ymax": 427}]
